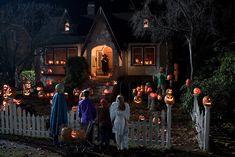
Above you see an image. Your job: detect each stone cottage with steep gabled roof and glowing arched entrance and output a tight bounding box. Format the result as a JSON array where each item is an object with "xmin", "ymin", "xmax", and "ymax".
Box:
[{"xmin": 35, "ymin": 2, "xmax": 171, "ymax": 84}]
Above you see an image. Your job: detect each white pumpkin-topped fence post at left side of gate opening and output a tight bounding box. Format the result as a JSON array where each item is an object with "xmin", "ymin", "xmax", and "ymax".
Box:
[{"xmin": 166, "ymin": 104, "xmax": 172, "ymax": 148}]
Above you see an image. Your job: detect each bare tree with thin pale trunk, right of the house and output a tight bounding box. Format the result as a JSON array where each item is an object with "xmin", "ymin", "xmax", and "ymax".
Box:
[{"xmin": 131, "ymin": 0, "xmax": 216, "ymax": 79}]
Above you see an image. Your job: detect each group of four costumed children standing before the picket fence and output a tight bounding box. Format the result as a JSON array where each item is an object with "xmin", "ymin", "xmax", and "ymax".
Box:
[{"xmin": 50, "ymin": 84, "xmax": 130, "ymax": 150}]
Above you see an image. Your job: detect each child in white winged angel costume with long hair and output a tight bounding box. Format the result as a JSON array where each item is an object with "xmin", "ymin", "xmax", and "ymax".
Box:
[{"xmin": 110, "ymin": 95, "xmax": 130, "ymax": 150}]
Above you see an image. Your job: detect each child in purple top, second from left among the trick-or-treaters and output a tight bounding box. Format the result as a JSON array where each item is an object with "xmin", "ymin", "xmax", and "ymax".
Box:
[{"xmin": 78, "ymin": 89, "xmax": 96, "ymax": 143}]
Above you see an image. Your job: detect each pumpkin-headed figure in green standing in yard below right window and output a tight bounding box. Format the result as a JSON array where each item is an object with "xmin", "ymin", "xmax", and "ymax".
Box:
[{"xmin": 153, "ymin": 67, "xmax": 166, "ymax": 95}]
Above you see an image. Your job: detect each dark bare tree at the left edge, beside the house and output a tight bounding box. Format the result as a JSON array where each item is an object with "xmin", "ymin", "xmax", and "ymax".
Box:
[{"xmin": 0, "ymin": 0, "xmax": 60, "ymax": 85}]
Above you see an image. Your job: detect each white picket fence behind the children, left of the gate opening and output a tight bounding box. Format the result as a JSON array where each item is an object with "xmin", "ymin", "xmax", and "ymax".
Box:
[{"xmin": 0, "ymin": 104, "xmax": 167, "ymax": 147}]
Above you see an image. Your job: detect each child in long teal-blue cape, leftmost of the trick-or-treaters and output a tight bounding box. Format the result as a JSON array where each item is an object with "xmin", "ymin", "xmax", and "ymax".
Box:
[{"xmin": 50, "ymin": 83, "xmax": 68, "ymax": 145}]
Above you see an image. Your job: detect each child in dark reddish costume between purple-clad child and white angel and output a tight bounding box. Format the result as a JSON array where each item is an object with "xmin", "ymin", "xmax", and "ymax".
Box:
[{"xmin": 99, "ymin": 98, "xmax": 112, "ymax": 148}]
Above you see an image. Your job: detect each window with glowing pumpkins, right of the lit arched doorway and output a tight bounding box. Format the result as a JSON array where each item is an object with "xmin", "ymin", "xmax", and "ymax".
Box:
[{"xmin": 131, "ymin": 46, "xmax": 156, "ymax": 65}]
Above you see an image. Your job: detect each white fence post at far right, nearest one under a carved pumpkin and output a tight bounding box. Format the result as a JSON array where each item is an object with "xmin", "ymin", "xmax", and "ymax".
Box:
[{"xmin": 203, "ymin": 106, "xmax": 210, "ymax": 151}]
